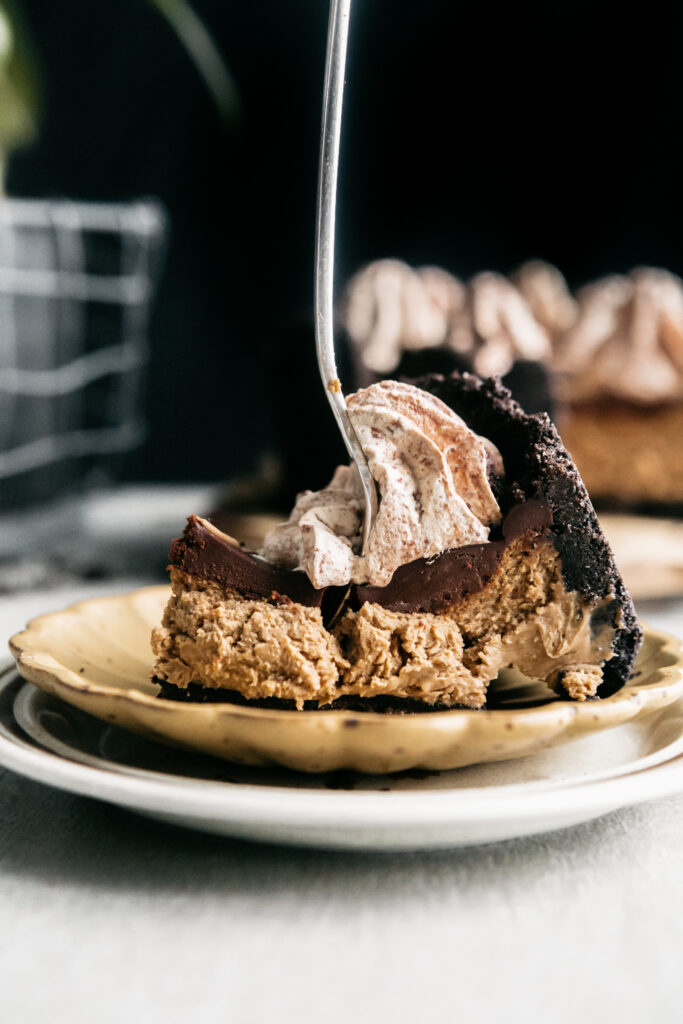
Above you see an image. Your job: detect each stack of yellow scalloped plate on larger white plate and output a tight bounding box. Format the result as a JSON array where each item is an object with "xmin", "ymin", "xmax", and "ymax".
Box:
[{"xmin": 0, "ymin": 588, "xmax": 683, "ymax": 850}]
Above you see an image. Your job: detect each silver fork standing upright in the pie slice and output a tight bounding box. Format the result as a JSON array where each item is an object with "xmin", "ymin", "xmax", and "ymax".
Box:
[{"xmin": 315, "ymin": 0, "xmax": 377, "ymax": 554}]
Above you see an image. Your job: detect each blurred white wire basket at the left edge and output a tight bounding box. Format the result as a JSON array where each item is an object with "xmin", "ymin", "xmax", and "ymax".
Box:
[{"xmin": 0, "ymin": 200, "xmax": 167, "ymax": 509}]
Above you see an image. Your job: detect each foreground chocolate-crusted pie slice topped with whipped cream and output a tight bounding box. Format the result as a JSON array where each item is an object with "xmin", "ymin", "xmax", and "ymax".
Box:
[{"xmin": 153, "ymin": 373, "xmax": 641, "ymax": 711}]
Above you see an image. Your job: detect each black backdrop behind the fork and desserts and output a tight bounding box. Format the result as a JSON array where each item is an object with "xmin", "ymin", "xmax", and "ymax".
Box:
[{"xmin": 9, "ymin": 0, "xmax": 683, "ymax": 480}]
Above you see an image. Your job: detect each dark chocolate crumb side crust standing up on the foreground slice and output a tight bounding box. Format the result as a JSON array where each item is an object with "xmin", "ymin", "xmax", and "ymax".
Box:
[{"xmin": 411, "ymin": 373, "xmax": 642, "ymax": 697}]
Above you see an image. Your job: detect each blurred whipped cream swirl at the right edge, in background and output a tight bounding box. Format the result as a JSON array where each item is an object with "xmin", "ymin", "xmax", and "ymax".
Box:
[{"xmin": 556, "ymin": 268, "xmax": 683, "ymax": 404}]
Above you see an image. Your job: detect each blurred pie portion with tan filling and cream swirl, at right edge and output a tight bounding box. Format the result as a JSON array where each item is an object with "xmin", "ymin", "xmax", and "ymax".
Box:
[{"xmin": 554, "ymin": 268, "xmax": 683, "ymax": 512}]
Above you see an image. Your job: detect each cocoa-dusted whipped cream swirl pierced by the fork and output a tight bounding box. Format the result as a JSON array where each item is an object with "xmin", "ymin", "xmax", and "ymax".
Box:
[{"xmin": 261, "ymin": 381, "xmax": 504, "ymax": 588}]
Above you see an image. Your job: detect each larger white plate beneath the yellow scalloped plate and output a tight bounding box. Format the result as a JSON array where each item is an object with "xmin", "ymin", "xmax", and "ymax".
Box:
[{"xmin": 0, "ymin": 670, "xmax": 683, "ymax": 850}]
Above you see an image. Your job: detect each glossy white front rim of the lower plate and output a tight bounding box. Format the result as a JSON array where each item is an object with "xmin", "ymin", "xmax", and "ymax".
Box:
[{"xmin": 0, "ymin": 666, "xmax": 683, "ymax": 831}]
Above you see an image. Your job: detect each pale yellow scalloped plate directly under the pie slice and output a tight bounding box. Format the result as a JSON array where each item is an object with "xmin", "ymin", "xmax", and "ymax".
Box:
[{"xmin": 10, "ymin": 587, "xmax": 683, "ymax": 773}]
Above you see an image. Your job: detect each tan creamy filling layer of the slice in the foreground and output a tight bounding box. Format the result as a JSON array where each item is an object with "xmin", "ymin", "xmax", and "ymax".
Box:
[{"xmin": 153, "ymin": 531, "xmax": 614, "ymax": 709}]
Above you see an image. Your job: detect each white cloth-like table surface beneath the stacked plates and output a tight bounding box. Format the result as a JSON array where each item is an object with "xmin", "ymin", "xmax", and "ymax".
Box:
[{"xmin": 0, "ymin": 496, "xmax": 683, "ymax": 1024}]
